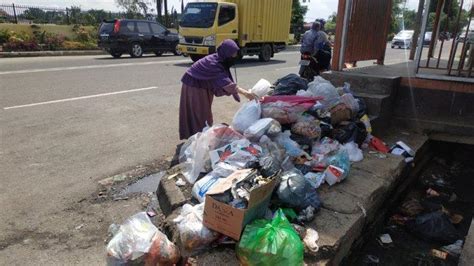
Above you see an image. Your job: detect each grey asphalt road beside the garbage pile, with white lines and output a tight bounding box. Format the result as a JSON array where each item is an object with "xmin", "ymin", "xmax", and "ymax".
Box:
[{"xmin": 0, "ymin": 45, "xmax": 414, "ymax": 265}]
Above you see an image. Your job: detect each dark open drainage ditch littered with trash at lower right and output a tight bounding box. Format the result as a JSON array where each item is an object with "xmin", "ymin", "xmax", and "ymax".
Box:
[{"xmin": 343, "ymin": 141, "xmax": 474, "ymax": 265}]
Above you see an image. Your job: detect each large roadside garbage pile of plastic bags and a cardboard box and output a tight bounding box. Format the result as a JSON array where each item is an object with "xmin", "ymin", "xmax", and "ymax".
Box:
[{"xmin": 104, "ymin": 74, "xmax": 396, "ymax": 265}]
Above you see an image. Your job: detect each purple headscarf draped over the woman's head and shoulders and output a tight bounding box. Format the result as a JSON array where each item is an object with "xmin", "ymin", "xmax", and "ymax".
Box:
[{"xmin": 186, "ymin": 40, "xmax": 239, "ymax": 81}]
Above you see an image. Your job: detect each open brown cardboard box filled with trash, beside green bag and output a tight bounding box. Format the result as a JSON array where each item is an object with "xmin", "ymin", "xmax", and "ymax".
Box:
[{"xmin": 203, "ymin": 169, "xmax": 277, "ymax": 241}]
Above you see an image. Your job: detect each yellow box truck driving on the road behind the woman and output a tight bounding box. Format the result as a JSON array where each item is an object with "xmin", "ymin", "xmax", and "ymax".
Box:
[{"xmin": 178, "ymin": 0, "xmax": 291, "ymax": 62}]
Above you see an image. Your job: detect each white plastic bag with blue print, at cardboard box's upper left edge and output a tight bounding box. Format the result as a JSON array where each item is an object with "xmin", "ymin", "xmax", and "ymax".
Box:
[{"xmin": 192, "ymin": 163, "xmax": 239, "ymax": 202}]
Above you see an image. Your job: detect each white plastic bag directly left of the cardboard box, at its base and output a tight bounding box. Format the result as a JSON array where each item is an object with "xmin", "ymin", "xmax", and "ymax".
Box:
[{"xmin": 173, "ymin": 203, "xmax": 219, "ymax": 257}]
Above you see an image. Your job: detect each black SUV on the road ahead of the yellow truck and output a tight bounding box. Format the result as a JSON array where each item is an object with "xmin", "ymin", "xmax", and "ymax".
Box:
[{"xmin": 98, "ymin": 19, "xmax": 179, "ymax": 58}]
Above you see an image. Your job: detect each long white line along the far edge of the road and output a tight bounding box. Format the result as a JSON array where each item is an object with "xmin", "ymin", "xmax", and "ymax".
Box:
[{"xmin": 0, "ymin": 59, "xmax": 191, "ymax": 75}]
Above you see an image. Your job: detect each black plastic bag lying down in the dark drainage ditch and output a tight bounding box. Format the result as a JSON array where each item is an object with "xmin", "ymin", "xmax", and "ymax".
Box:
[{"xmin": 406, "ymin": 211, "xmax": 462, "ymax": 245}]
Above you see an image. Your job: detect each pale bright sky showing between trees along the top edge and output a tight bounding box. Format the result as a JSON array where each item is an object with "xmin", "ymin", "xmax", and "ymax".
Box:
[{"xmin": 12, "ymin": 0, "xmax": 418, "ymax": 22}]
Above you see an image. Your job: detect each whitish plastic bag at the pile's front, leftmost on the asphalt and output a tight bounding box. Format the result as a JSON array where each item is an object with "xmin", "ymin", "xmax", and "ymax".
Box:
[{"xmin": 107, "ymin": 212, "xmax": 158, "ymax": 263}]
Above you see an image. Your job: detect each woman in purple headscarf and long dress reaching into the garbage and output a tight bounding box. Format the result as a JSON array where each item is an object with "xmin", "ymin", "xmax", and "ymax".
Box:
[{"xmin": 179, "ymin": 40, "xmax": 256, "ymax": 139}]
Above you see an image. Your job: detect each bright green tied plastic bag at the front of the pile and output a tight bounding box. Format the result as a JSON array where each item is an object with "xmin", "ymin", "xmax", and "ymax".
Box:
[{"xmin": 237, "ymin": 209, "xmax": 304, "ymax": 266}]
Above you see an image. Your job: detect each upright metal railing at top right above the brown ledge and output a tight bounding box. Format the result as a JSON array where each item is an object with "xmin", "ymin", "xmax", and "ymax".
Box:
[{"xmin": 415, "ymin": 0, "xmax": 474, "ymax": 82}]
